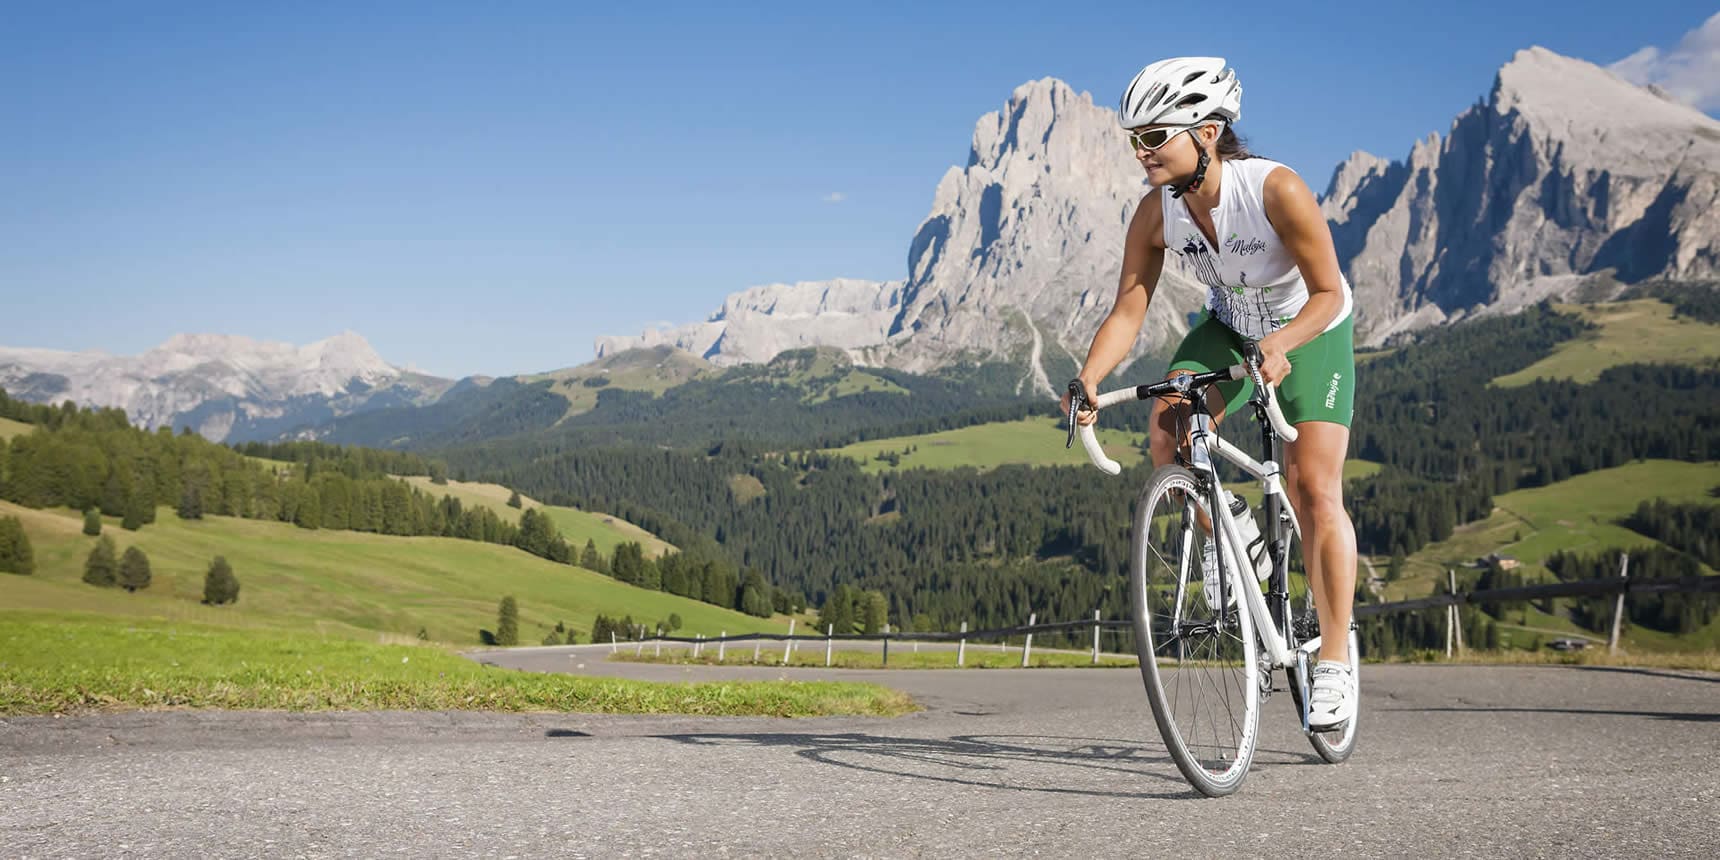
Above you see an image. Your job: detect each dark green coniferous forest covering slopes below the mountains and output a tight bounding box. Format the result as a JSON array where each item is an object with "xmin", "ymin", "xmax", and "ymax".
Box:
[{"xmin": 0, "ymin": 289, "xmax": 1720, "ymax": 650}]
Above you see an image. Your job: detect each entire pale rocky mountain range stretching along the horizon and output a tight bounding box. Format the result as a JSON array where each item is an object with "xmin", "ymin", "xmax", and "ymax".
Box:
[{"xmin": 0, "ymin": 48, "xmax": 1720, "ymax": 444}]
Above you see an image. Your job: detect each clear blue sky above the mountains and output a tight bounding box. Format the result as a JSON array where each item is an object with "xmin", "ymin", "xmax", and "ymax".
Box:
[{"xmin": 0, "ymin": 0, "xmax": 1713, "ymax": 377}]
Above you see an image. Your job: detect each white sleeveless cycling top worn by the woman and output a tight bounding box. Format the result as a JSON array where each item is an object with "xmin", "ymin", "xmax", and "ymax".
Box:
[{"xmin": 1159, "ymin": 158, "xmax": 1354, "ymax": 341}]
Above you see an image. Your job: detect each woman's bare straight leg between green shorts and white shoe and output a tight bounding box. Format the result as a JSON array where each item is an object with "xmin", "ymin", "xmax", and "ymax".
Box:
[{"xmin": 1285, "ymin": 421, "xmax": 1355, "ymax": 662}]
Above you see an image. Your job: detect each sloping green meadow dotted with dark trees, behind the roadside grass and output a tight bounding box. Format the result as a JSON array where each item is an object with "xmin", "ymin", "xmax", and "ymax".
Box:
[{"xmin": 0, "ymin": 502, "xmax": 788, "ymax": 645}]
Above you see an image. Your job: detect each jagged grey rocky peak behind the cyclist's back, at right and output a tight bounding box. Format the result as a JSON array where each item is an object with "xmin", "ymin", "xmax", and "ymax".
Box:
[{"xmin": 1323, "ymin": 48, "xmax": 1720, "ymax": 342}]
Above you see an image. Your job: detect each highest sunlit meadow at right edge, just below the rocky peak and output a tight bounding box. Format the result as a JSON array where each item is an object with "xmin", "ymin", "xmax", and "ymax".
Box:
[{"xmin": 1493, "ymin": 299, "xmax": 1720, "ymax": 389}]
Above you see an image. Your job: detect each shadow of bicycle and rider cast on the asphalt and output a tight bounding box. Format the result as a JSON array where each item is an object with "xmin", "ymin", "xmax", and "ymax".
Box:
[{"xmin": 639, "ymin": 731, "xmax": 1316, "ymax": 800}]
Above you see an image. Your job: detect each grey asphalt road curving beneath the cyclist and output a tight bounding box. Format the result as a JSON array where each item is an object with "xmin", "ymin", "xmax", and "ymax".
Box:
[{"xmin": 0, "ymin": 648, "xmax": 1720, "ymax": 858}]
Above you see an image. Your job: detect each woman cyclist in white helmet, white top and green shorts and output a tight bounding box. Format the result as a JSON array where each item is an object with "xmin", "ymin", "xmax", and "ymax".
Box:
[{"xmin": 1063, "ymin": 57, "xmax": 1355, "ymax": 731}]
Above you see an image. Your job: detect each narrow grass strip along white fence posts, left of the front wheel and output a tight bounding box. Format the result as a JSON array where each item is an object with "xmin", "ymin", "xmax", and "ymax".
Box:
[{"xmin": 611, "ymin": 642, "xmax": 1140, "ymax": 669}]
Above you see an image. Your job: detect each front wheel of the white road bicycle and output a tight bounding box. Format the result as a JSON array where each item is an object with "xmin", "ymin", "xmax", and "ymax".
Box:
[{"xmin": 1128, "ymin": 466, "xmax": 1261, "ymax": 796}]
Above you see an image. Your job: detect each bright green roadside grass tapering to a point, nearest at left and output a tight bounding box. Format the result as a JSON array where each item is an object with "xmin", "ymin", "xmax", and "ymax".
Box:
[{"xmin": 0, "ymin": 611, "xmax": 915, "ymax": 717}]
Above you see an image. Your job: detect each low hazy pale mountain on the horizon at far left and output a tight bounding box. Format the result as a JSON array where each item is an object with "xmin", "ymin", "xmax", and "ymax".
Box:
[{"xmin": 0, "ymin": 332, "xmax": 452, "ymax": 442}]
